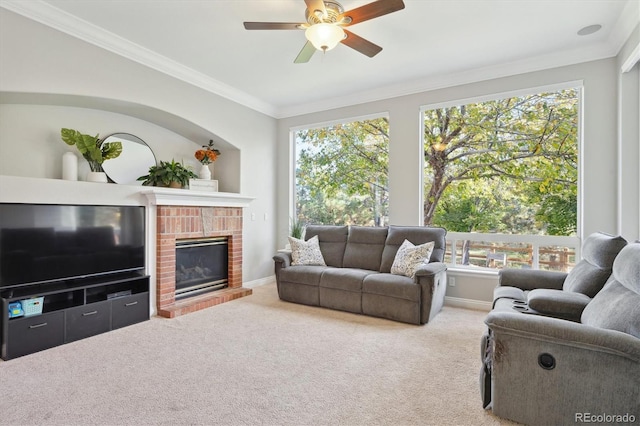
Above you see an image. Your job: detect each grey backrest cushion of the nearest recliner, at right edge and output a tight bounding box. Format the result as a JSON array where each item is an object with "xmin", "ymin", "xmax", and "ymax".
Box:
[{"xmin": 581, "ymin": 244, "xmax": 640, "ymax": 338}]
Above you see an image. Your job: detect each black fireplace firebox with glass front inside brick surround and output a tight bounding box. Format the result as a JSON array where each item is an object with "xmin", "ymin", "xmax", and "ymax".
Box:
[{"xmin": 175, "ymin": 237, "xmax": 229, "ymax": 300}]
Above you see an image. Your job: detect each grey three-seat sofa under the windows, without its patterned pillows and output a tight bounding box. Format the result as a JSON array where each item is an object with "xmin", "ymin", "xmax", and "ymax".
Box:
[{"xmin": 273, "ymin": 225, "xmax": 447, "ymax": 324}]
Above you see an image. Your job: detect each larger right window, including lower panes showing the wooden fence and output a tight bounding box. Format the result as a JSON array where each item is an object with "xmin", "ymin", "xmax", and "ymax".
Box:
[{"xmin": 424, "ymin": 88, "xmax": 580, "ymax": 270}]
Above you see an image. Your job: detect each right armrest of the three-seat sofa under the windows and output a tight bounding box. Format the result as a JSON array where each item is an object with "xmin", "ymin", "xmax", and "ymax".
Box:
[{"xmin": 414, "ymin": 262, "xmax": 447, "ymax": 324}]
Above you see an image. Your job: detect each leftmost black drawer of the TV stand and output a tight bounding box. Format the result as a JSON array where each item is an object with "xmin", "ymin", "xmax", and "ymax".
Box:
[{"xmin": 2, "ymin": 311, "xmax": 64, "ymax": 359}]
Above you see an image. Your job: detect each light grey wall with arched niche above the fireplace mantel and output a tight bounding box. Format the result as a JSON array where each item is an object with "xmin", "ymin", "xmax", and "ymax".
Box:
[{"xmin": 0, "ymin": 9, "xmax": 276, "ymax": 282}]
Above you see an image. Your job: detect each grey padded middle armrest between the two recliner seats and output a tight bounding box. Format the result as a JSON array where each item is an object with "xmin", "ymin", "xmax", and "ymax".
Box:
[{"xmin": 527, "ymin": 288, "xmax": 591, "ymax": 322}]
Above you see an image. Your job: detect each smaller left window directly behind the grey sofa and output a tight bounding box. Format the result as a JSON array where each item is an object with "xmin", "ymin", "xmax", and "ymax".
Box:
[{"xmin": 294, "ymin": 117, "xmax": 389, "ymax": 226}]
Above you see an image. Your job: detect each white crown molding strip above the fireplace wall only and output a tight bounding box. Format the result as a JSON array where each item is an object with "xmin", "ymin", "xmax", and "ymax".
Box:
[{"xmin": 0, "ymin": 0, "xmax": 276, "ymax": 117}]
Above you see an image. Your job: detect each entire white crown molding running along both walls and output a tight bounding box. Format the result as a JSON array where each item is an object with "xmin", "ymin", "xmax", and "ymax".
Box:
[{"xmin": 0, "ymin": 0, "xmax": 640, "ymax": 119}]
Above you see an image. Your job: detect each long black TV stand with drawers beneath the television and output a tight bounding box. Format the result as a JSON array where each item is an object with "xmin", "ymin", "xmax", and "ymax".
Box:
[{"xmin": 0, "ymin": 273, "xmax": 149, "ymax": 360}]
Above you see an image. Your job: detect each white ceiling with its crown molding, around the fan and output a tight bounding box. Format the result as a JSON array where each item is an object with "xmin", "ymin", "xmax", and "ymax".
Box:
[{"xmin": 0, "ymin": 0, "xmax": 640, "ymax": 117}]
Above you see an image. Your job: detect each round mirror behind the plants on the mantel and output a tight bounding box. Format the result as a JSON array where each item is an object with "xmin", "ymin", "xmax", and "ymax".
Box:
[{"xmin": 102, "ymin": 133, "xmax": 156, "ymax": 185}]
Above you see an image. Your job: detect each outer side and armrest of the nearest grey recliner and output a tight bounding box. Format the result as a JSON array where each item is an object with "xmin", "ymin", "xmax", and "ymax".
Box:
[{"xmin": 485, "ymin": 311, "xmax": 640, "ymax": 424}]
